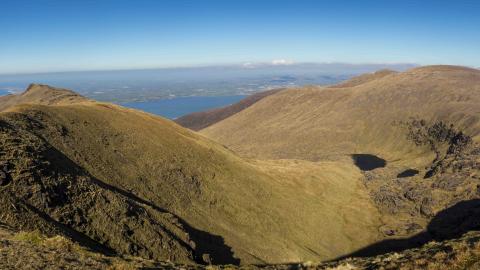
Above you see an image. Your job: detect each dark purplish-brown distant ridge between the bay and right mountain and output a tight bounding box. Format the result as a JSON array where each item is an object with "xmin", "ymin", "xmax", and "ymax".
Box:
[{"xmin": 175, "ymin": 89, "xmax": 282, "ymax": 130}]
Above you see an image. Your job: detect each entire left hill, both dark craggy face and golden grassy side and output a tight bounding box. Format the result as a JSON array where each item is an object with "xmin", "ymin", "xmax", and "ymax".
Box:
[{"xmin": 0, "ymin": 86, "xmax": 380, "ymax": 263}]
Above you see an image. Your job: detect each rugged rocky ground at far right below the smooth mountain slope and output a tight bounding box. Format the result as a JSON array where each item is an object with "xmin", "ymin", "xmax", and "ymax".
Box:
[{"xmin": 364, "ymin": 119, "xmax": 480, "ymax": 240}]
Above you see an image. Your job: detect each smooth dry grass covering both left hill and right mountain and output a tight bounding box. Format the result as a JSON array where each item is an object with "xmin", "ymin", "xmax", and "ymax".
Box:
[{"xmin": 2, "ymin": 68, "xmax": 480, "ymax": 267}]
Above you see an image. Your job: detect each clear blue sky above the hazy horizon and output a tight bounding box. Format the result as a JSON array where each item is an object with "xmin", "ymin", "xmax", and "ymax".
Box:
[{"xmin": 0, "ymin": 0, "xmax": 480, "ymax": 73}]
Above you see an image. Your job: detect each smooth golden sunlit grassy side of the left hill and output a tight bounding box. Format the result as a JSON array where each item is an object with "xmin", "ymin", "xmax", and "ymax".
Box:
[{"xmin": 3, "ymin": 86, "xmax": 379, "ymax": 263}]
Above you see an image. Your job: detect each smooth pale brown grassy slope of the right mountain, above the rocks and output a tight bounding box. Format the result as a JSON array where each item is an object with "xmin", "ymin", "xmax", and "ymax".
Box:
[{"xmin": 201, "ymin": 66, "xmax": 480, "ymax": 160}]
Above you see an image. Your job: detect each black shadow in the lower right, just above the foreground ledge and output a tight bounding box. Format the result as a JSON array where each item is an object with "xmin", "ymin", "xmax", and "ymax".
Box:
[{"xmin": 335, "ymin": 199, "xmax": 480, "ymax": 260}]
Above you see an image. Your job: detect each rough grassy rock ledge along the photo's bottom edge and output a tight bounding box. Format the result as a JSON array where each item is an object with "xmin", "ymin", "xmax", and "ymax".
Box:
[{"xmin": 0, "ymin": 224, "xmax": 480, "ymax": 270}]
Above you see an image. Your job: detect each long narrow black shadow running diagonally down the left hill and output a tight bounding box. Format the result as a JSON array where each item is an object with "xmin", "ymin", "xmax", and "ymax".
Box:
[{"xmin": 40, "ymin": 142, "xmax": 240, "ymax": 265}]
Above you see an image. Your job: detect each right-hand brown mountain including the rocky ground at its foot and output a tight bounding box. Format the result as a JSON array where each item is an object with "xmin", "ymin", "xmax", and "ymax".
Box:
[{"xmin": 201, "ymin": 66, "xmax": 480, "ymax": 249}]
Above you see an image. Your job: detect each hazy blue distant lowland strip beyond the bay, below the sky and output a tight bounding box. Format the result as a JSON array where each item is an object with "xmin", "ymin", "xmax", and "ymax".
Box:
[{"xmin": 0, "ymin": 62, "xmax": 415, "ymax": 102}]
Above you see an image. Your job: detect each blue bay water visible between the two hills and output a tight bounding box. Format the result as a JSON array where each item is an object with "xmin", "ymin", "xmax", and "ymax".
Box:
[{"xmin": 119, "ymin": 95, "xmax": 246, "ymax": 119}]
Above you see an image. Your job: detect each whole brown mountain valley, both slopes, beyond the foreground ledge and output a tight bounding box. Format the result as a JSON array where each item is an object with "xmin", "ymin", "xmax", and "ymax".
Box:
[{"xmin": 0, "ymin": 66, "xmax": 480, "ymax": 269}]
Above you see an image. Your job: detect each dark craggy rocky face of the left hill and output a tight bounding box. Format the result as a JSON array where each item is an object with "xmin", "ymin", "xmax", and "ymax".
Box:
[{"xmin": 0, "ymin": 107, "xmax": 201, "ymax": 263}]
